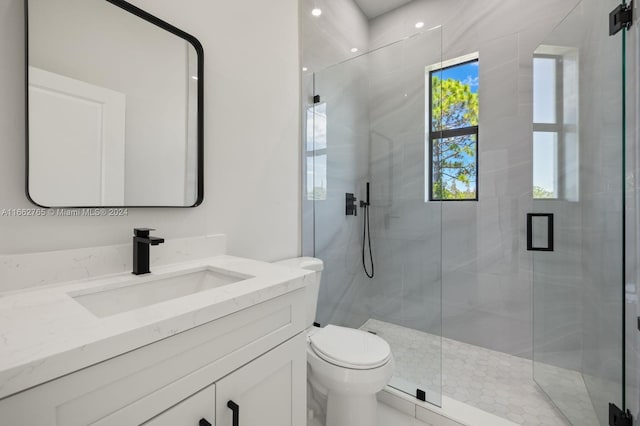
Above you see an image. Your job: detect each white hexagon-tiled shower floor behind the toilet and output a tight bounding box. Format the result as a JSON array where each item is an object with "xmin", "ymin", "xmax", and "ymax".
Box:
[{"xmin": 361, "ymin": 319, "xmax": 598, "ymax": 426}]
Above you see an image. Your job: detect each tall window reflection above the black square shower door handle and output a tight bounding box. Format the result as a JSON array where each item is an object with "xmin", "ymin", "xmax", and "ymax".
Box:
[{"xmin": 533, "ymin": 46, "xmax": 579, "ymax": 201}]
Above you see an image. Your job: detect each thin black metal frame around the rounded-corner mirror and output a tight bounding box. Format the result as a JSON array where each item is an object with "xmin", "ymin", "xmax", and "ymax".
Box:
[{"xmin": 24, "ymin": 0, "xmax": 204, "ymax": 209}]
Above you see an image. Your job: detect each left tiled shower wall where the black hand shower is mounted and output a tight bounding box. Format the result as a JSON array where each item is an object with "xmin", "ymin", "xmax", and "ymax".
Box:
[{"xmin": 300, "ymin": 0, "xmax": 369, "ymax": 326}]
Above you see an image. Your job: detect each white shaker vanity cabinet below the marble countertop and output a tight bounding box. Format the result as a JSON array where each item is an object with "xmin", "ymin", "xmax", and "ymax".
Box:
[{"xmin": 0, "ymin": 288, "xmax": 306, "ymax": 426}]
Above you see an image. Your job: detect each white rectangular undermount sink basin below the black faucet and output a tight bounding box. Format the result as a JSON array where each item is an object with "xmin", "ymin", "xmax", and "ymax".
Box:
[{"xmin": 69, "ymin": 268, "xmax": 253, "ymax": 317}]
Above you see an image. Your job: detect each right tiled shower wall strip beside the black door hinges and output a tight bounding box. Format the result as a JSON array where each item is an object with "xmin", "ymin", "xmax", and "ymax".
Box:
[{"xmin": 579, "ymin": 0, "xmax": 624, "ymax": 424}]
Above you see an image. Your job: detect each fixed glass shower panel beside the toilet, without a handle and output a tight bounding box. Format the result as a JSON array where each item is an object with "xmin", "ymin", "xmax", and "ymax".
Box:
[{"xmin": 306, "ymin": 28, "xmax": 442, "ymax": 405}]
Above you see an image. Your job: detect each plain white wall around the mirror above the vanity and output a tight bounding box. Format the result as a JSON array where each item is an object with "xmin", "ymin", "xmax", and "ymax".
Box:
[{"xmin": 0, "ymin": 0, "xmax": 300, "ymax": 272}]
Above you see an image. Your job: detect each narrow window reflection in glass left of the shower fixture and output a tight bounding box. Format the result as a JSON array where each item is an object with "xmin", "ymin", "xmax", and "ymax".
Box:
[{"xmin": 305, "ymin": 103, "xmax": 327, "ymax": 201}]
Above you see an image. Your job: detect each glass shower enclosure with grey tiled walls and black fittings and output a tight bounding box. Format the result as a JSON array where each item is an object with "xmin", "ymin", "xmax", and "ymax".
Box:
[{"xmin": 302, "ymin": 0, "xmax": 625, "ymax": 426}]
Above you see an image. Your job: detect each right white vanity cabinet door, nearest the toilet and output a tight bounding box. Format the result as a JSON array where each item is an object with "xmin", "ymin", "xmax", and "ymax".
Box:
[{"xmin": 216, "ymin": 333, "xmax": 307, "ymax": 426}]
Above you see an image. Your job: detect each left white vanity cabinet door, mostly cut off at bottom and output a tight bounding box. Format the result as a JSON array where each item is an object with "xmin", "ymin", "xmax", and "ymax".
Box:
[{"xmin": 143, "ymin": 385, "xmax": 216, "ymax": 426}]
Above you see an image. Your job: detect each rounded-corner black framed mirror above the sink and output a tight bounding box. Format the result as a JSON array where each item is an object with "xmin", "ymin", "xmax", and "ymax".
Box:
[{"xmin": 25, "ymin": 0, "xmax": 204, "ymax": 208}]
